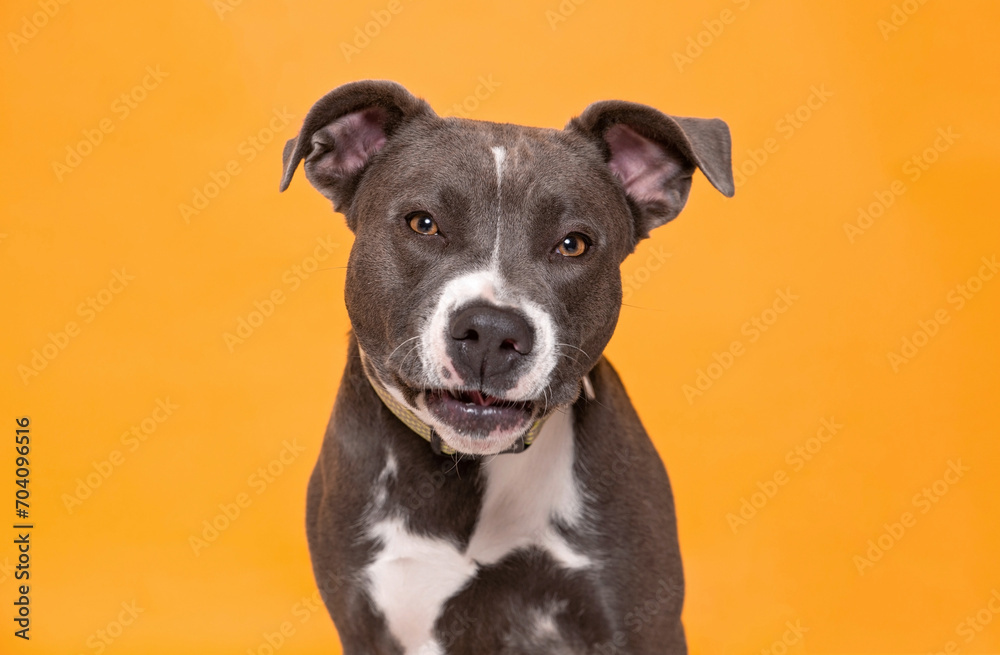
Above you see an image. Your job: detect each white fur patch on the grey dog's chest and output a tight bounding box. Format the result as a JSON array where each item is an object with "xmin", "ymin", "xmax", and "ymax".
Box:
[{"xmin": 365, "ymin": 410, "xmax": 591, "ymax": 655}]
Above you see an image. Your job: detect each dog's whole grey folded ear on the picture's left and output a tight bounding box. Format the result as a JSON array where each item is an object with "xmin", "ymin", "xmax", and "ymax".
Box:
[{"xmin": 279, "ymin": 80, "xmax": 434, "ymax": 213}]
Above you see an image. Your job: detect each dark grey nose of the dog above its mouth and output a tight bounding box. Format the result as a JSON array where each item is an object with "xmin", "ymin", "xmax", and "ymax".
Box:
[{"xmin": 449, "ymin": 305, "xmax": 534, "ymax": 383}]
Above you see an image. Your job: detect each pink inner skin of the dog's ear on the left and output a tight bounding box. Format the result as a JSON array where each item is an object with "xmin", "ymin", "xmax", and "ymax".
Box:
[{"xmin": 310, "ymin": 107, "xmax": 386, "ymax": 177}]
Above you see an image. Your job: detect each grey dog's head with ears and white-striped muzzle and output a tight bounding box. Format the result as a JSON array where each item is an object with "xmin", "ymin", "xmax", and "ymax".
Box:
[{"xmin": 281, "ymin": 81, "xmax": 733, "ymax": 454}]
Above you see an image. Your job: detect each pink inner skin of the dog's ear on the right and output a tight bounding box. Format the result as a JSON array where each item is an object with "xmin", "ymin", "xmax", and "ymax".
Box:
[{"xmin": 604, "ymin": 123, "xmax": 682, "ymax": 202}]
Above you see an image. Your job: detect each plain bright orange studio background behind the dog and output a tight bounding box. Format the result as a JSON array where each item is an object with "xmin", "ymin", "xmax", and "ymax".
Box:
[{"xmin": 0, "ymin": 0, "xmax": 1000, "ymax": 655}]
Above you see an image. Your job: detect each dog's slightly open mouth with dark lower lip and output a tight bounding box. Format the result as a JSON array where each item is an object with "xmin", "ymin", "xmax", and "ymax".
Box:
[{"xmin": 424, "ymin": 389, "xmax": 535, "ymax": 438}]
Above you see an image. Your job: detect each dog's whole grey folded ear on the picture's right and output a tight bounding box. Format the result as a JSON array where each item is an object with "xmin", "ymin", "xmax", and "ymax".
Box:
[{"xmin": 566, "ymin": 100, "xmax": 736, "ymax": 240}]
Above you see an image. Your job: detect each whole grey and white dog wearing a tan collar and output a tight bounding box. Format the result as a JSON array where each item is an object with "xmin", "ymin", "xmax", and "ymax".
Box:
[{"xmin": 280, "ymin": 80, "xmax": 734, "ymax": 655}]
